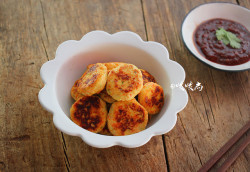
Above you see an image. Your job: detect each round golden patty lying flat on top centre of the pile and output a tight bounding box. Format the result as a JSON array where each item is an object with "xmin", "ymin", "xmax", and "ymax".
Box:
[{"xmin": 106, "ymin": 64, "xmax": 143, "ymax": 101}]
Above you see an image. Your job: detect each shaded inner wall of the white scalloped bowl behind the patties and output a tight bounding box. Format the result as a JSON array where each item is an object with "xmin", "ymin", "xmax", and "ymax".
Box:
[{"xmin": 55, "ymin": 43, "xmax": 172, "ymax": 128}]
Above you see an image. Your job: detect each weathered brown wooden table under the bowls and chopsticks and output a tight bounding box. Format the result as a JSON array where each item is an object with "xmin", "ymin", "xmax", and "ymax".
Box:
[{"xmin": 0, "ymin": 0, "xmax": 250, "ymax": 172}]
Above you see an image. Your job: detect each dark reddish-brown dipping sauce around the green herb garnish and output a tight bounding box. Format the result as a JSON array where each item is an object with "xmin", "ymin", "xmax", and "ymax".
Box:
[{"xmin": 194, "ymin": 19, "xmax": 250, "ymax": 66}]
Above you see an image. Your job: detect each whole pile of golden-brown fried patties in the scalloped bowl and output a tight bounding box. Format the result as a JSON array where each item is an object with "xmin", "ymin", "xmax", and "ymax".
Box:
[{"xmin": 70, "ymin": 62, "xmax": 164, "ymax": 136}]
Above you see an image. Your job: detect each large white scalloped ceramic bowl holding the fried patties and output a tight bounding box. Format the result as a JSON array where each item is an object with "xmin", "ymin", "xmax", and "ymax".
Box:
[{"xmin": 38, "ymin": 31, "xmax": 188, "ymax": 148}]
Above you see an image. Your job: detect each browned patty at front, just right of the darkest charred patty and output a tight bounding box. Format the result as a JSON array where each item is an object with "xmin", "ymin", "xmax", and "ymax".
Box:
[{"xmin": 107, "ymin": 99, "xmax": 148, "ymax": 136}]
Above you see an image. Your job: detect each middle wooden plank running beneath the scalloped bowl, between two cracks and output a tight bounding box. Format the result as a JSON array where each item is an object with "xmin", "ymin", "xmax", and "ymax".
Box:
[{"xmin": 41, "ymin": 0, "xmax": 167, "ymax": 171}]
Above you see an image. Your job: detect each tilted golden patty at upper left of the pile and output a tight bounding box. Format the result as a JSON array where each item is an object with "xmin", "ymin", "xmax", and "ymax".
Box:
[{"xmin": 77, "ymin": 63, "xmax": 107, "ymax": 96}]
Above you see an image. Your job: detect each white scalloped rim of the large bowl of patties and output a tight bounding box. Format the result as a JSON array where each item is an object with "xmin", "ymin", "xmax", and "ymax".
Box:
[{"xmin": 38, "ymin": 31, "xmax": 188, "ymax": 148}]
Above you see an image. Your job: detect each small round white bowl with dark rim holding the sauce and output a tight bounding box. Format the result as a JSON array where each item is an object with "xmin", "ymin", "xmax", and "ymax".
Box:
[{"xmin": 181, "ymin": 2, "xmax": 250, "ymax": 71}]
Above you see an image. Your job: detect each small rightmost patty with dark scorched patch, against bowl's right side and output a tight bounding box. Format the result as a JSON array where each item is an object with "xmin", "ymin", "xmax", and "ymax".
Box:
[{"xmin": 138, "ymin": 82, "xmax": 164, "ymax": 115}]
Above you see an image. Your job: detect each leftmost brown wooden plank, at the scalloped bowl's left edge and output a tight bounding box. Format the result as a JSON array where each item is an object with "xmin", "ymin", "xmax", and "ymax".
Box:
[{"xmin": 0, "ymin": 0, "xmax": 66, "ymax": 171}]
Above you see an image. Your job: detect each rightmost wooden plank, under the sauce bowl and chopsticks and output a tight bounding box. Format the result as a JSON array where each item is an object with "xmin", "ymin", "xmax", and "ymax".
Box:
[{"xmin": 143, "ymin": 0, "xmax": 250, "ymax": 171}]
